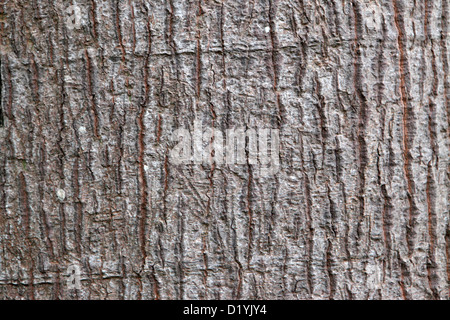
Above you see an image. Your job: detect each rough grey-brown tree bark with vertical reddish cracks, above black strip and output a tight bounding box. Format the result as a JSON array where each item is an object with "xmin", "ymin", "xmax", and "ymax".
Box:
[{"xmin": 0, "ymin": 0, "xmax": 450, "ymax": 299}]
